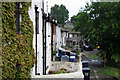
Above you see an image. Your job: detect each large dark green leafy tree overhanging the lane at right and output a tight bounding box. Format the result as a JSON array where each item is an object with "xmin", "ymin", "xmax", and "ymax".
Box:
[{"xmin": 72, "ymin": 2, "xmax": 120, "ymax": 62}]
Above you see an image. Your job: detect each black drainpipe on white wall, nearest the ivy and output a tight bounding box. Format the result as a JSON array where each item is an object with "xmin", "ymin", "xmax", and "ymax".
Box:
[{"xmin": 35, "ymin": 5, "xmax": 40, "ymax": 75}]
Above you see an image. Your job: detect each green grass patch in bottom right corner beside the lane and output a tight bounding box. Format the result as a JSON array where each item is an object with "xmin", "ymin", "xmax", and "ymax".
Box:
[{"xmin": 97, "ymin": 66, "xmax": 120, "ymax": 80}]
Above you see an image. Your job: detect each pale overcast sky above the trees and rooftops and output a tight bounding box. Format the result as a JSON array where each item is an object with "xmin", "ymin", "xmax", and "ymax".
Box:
[{"xmin": 44, "ymin": 0, "xmax": 90, "ymax": 17}]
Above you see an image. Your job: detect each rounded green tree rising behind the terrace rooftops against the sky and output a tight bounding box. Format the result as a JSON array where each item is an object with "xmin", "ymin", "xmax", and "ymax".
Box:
[{"xmin": 51, "ymin": 4, "xmax": 69, "ymax": 25}]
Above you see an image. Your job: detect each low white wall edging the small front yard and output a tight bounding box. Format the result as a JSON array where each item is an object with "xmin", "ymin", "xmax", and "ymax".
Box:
[{"xmin": 31, "ymin": 49, "xmax": 84, "ymax": 80}]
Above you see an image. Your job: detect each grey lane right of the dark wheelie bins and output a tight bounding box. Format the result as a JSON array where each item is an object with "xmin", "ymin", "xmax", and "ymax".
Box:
[{"xmin": 82, "ymin": 49, "xmax": 118, "ymax": 80}]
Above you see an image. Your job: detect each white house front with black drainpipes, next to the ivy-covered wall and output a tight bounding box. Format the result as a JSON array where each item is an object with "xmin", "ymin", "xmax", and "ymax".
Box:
[{"xmin": 29, "ymin": 0, "xmax": 54, "ymax": 76}]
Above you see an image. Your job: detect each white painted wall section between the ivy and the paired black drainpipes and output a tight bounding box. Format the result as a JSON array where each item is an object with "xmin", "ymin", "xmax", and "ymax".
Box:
[{"xmin": 29, "ymin": 0, "xmax": 43, "ymax": 75}]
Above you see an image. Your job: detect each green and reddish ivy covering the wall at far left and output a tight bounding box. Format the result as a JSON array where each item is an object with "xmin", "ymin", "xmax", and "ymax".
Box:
[{"xmin": 2, "ymin": 2, "xmax": 35, "ymax": 79}]
